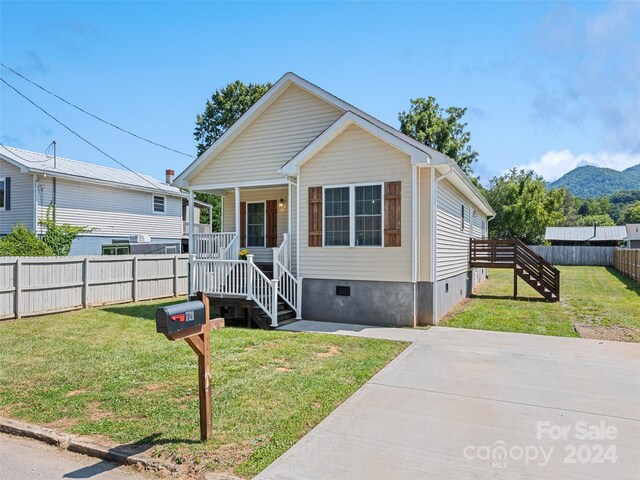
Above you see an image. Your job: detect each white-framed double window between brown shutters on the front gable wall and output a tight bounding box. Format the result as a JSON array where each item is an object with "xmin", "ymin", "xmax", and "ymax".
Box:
[{"xmin": 323, "ymin": 184, "xmax": 383, "ymax": 247}]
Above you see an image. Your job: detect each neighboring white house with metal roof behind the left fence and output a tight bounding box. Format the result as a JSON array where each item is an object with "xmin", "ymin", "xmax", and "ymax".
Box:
[{"xmin": 0, "ymin": 146, "xmax": 211, "ymax": 255}]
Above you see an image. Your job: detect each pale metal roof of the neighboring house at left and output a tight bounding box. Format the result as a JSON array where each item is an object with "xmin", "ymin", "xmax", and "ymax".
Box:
[{"xmin": 0, "ymin": 145, "xmax": 186, "ymax": 197}]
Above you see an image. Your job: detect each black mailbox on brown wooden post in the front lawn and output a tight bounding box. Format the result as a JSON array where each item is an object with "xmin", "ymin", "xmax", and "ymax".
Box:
[{"xmin": 156, "ymin": 292, "xmax": 224, "ymax": 441}]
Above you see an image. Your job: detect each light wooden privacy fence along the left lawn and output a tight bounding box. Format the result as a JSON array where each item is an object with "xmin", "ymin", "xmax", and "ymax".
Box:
[{"xmin": 0, "ymin": 255, "xmax": 189, "ymax": 319}]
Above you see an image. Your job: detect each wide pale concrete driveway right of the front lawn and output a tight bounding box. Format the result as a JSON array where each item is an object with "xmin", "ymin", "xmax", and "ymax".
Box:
[{"xmin": 256, "ymin": 327, "xmax": 640, "ymax": 480}]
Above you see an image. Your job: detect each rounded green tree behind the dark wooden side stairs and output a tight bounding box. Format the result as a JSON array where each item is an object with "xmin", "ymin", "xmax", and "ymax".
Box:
[{"xmin": 487, "ymin": 168, "xmax": 565, "ymax": 244}]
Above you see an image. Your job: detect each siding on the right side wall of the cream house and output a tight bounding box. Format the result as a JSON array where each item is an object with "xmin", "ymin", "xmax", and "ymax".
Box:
[{"xmin": 436, "ymin": 180, "xmax": 486, "ymax": 280}]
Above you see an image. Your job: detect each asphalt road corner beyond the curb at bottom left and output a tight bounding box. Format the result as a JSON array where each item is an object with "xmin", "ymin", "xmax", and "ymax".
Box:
[{"xmin": 0, "ymin": 434, "xmax": 151, "ymax": 480}]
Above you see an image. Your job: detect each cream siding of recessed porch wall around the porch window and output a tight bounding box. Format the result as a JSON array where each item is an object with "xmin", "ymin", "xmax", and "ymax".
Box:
[{"xmin": 222, "ymin": 187, "xmax": 288, "ymax": 263}]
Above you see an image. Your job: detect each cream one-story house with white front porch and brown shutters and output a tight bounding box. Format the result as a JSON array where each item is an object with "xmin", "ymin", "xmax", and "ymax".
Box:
[{"xmin": 174, "ymin": 73, "xmax": 494, "ymax": 326}]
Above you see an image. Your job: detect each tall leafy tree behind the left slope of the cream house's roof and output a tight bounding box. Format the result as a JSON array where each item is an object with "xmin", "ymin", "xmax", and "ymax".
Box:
[{"xmin": 193, "ymin": 80, "xmax": 271, "ymax": 232}]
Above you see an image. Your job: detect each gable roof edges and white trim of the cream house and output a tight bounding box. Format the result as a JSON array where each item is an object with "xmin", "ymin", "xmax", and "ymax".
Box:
[{"xmin": 173, "ymin": 72, "xmax": 495, "ymax": 215}]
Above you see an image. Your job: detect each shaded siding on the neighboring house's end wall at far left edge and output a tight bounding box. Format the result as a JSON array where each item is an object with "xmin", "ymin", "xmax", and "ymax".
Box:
[{"xmin": 0, "ymin": 159, "xmax": 34, "ymax": 235}]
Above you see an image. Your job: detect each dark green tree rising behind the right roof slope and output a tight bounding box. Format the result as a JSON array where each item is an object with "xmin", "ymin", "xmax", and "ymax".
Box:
[{"xmin": 398, "ymin": 97, "xmax": 478, "ymax": 175}]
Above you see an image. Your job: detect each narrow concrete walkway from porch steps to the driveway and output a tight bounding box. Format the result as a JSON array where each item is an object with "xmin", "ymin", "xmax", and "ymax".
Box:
[{"xmin": 278, "ymin": 320, "xmax": 425, "ymax": 342}]
